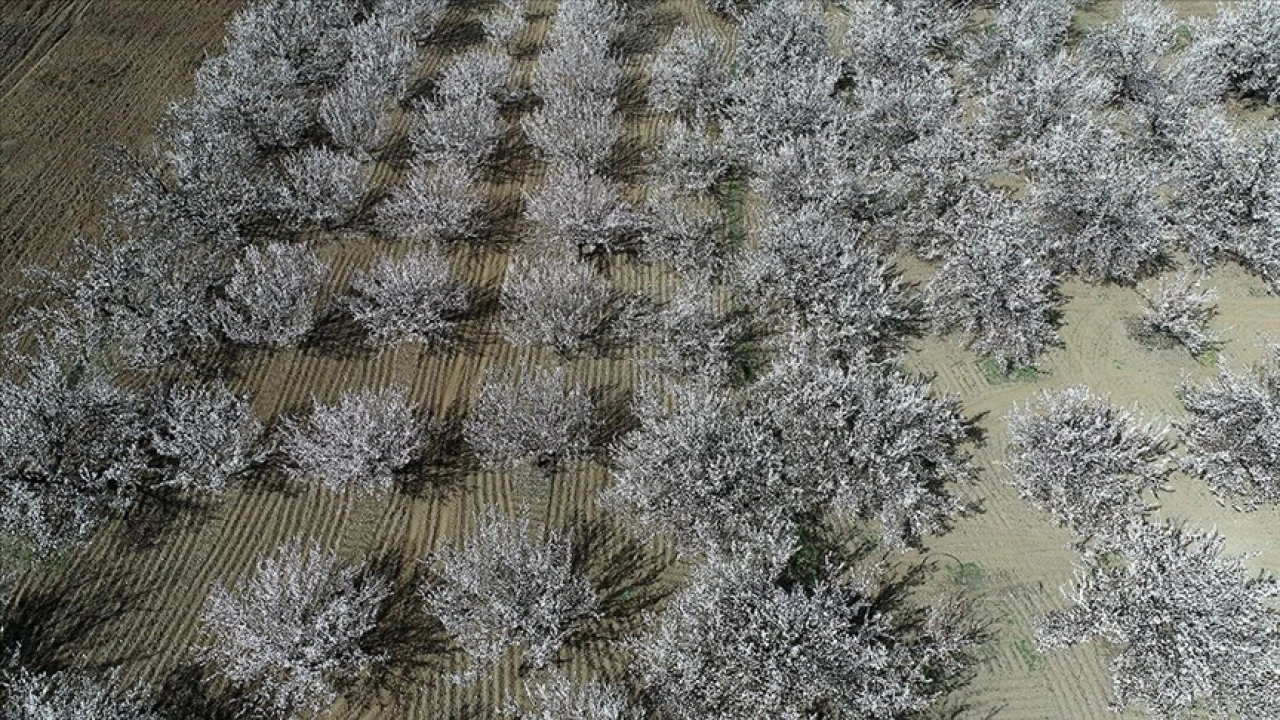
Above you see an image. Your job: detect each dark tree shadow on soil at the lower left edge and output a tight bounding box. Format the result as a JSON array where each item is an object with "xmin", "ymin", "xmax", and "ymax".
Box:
[{"xmin": 0, "ymin": 564, "xmax": 157, "ymax": 673}]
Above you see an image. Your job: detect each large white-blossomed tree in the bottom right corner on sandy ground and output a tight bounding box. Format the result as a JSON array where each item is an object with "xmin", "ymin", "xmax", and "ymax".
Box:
[{"xmin": 1039, "ymin": 521, "xmax": 1280, "ymax": 720}]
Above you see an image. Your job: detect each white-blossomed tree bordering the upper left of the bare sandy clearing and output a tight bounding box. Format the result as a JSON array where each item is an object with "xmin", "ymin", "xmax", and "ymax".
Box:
[{"xmin": 925, "ymin": 190, "xmax": 1059, "ymax": 368}]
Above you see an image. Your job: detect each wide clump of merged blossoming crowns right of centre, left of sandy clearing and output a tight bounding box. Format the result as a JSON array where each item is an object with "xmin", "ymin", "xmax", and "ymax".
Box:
[{"xmin": 604, "ymin": 352, "xmax": 972, "ymax": 550}]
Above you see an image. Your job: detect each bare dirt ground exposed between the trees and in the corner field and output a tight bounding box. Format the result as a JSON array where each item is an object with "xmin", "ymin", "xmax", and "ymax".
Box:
[{"xmin": 0, "ymin": 0, "xmax": 1280, "ymax": 720}]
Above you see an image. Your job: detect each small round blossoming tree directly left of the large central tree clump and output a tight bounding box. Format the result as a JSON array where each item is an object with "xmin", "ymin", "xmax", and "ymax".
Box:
[{"xmin": 463, "ymin": 364, "xmax": 593, "ymax": 468}]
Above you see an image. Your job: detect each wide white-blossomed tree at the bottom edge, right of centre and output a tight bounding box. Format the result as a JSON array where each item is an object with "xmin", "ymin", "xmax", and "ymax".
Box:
[{"xmin": 628, "ymin": 543, "xmax": 974, "ymax": 720}]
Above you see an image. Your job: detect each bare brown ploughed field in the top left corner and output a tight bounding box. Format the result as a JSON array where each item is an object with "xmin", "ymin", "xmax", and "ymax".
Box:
[{"xmin": 0, "ymin": 0, "xmax": 242, "ymax": 314}]
